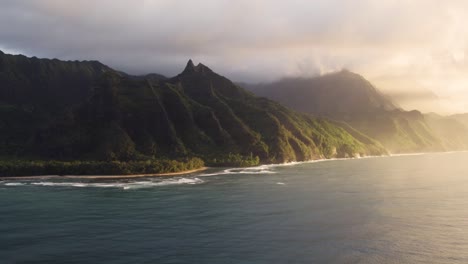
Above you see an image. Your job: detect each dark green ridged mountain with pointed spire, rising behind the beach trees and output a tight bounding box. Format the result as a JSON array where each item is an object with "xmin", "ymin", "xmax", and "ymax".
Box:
[{"xmin": 0, "ymin": 50, "xmax": 385, "ymax": 164}]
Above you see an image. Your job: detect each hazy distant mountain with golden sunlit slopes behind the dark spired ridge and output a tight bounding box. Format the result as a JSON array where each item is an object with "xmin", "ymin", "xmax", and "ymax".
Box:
[{"xmin": 249, "ymin": 70, "xmax": 445, "ymax": 153}]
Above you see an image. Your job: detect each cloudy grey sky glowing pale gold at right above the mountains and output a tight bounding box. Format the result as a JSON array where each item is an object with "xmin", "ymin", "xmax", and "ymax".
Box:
[{"xmin": 0, "ymin": 0, "xmax": 468, "ymax": 113}]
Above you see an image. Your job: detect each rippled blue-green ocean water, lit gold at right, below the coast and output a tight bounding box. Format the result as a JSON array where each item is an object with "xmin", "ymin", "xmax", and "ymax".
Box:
[{"xmin": 0, "ymin": 153, "xmax": 468, "ymax": 264}]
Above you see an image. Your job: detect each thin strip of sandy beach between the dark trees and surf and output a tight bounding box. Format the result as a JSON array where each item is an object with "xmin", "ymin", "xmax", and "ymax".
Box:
[{"xmin": 0, "ymin": 167, "xmax": 208, "ymax": 180}]
